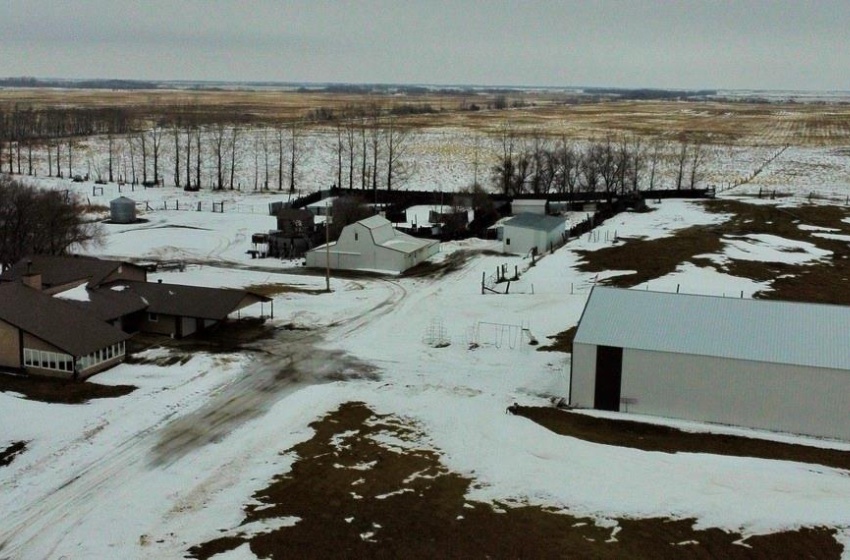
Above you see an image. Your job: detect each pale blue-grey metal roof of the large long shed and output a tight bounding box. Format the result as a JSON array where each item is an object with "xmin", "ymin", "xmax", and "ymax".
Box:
[{"xmin": 574, "ymin": 286, "xmax": 850, "ymax": 369}]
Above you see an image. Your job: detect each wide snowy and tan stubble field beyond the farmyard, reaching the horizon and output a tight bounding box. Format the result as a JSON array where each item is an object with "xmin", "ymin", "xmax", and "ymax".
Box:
[{"xmin": 0, "ymin": 89, "xmax": 850, "ymax": 201}]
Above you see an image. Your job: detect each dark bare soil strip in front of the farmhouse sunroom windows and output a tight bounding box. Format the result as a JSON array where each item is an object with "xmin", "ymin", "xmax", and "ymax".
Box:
[{"xmin": 0, "ymin": 372, "xmax": 136, "ymax": 404}]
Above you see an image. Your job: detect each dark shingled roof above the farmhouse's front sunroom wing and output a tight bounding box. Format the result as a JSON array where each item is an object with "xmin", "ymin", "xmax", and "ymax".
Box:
[{"xmin": 0, "ymin": 282, "xmax": 130, "ymax": 357}]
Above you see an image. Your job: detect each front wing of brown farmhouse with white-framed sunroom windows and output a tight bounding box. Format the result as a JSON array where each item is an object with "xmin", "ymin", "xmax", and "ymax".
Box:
[{"xmin": 0, "ymin": 282, "xmax": 130, "ymax": 379}]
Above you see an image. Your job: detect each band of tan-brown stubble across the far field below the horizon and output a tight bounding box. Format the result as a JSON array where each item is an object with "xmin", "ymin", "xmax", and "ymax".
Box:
[{"xmin": 6, "ymin": 88, "xmax": 850, "ymax": 146}]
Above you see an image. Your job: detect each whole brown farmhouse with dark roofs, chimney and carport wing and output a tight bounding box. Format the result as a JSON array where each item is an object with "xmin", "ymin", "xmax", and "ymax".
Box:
[{"xmin": 0, "ymin": 256, "xmax": 274, "ymax": 379}]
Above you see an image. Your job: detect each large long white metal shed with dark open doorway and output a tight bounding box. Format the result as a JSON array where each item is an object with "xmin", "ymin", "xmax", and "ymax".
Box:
[{"xmin": 569, "ymin": 287, "xmax": 850, "ymax": 440}]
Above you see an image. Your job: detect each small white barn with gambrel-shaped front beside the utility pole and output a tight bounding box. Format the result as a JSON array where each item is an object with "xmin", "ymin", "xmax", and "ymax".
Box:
[{"xmin": 305, "ymin": 216, "xmax": 440, "ymax": 273}]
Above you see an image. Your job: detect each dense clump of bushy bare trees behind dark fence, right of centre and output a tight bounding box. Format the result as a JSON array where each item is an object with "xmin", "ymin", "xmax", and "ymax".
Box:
[{"xmin": 491, "ymin": 125, "xmax": 706, "ymax": 201}]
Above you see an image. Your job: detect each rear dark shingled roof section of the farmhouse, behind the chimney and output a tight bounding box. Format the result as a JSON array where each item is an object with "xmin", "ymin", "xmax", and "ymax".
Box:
[{"xmin": 0, "ymin": 255, "xmax": 146, "ymax": 289}]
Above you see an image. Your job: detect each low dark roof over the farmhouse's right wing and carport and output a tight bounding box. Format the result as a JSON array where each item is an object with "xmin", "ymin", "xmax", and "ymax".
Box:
[{"xmin": 101, "ymin": 280, "xmax": 271, "ymax": 321}]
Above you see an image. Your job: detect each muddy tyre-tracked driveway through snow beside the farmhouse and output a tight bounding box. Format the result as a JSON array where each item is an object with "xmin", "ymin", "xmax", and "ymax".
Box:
[{"xmin": 0, "ymin": 279, "xmax": 407, "ymax": 560}]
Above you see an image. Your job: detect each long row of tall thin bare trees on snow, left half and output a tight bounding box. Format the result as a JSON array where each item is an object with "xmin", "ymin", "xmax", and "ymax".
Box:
[{"xmin": 0, "ymin": 105, "xmax": 414, "ymax": 197}]
